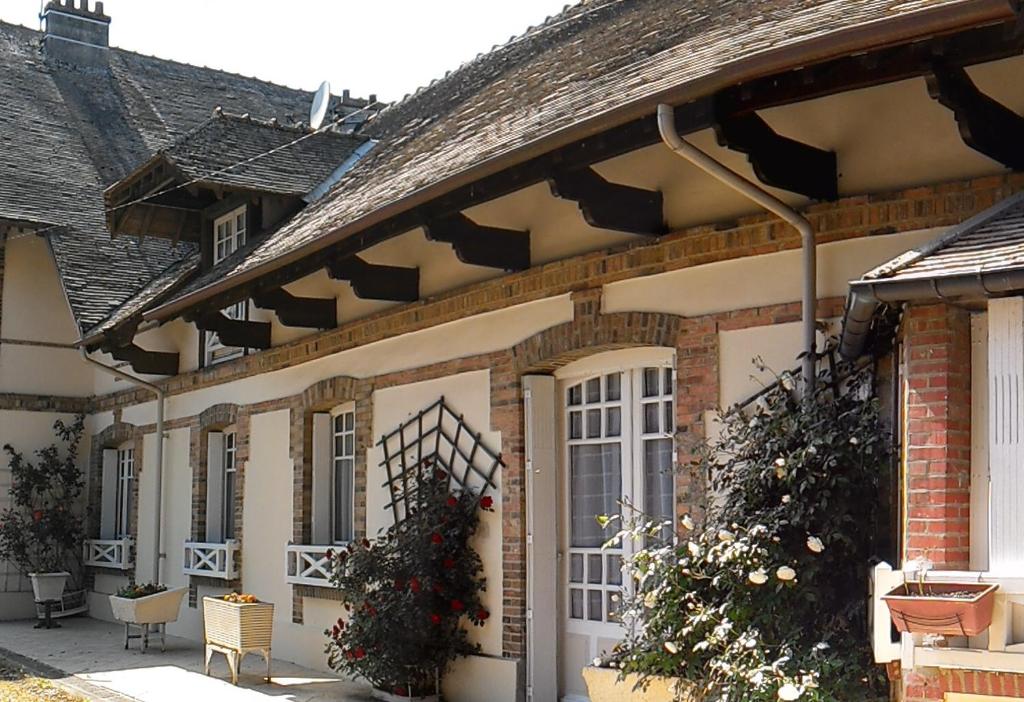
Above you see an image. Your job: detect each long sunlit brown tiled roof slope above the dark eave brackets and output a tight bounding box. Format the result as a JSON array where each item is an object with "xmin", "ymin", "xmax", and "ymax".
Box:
[{"xmin": 158, "ymin": 0, "xmax": 999, "ymax": 314}]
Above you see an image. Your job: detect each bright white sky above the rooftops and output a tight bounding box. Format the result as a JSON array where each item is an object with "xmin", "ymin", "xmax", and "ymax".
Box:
[{"xmin": 0, "ymin": 0, "xmax": 574, "ymax": 100}]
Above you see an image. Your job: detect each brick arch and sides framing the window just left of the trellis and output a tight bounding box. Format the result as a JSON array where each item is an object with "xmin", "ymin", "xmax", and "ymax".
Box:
[{"xmin": 291, "ymin": 376, "xmax": 373, "ymax": 543}]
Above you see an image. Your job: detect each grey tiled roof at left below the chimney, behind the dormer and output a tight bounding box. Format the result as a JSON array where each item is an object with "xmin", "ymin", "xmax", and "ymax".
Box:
[{"xmin": 0, "ymin": 18, "xmax": 368, "ymax": 332}]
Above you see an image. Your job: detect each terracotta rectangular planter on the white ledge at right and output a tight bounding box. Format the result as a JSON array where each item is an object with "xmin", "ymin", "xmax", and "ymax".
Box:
[{"xmin": 882, "ymin": 582, "xmax": 999, "ymax": 637}]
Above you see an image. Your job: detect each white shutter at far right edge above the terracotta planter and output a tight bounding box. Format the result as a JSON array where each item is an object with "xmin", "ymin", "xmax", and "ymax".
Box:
[{"xmin": 988, "ymin": 298, "xmax": 1024, "ymax": 570}]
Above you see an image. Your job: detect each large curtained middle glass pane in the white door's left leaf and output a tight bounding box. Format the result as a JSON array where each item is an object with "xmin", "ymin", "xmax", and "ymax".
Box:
[{"xmin": 569, "ymin": 442, "xmax": 623, "ymax": 547}]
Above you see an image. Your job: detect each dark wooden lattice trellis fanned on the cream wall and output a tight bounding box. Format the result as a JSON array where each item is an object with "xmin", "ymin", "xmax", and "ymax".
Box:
[{"xmin": 377, "ymin": 397, "xmax": 505, "ymax": 524}]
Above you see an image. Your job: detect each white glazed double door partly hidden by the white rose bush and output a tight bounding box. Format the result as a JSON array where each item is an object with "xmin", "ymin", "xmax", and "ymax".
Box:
[{"xmin": 559, "ymin": 367, "xmax": 675, "ymax": 701}]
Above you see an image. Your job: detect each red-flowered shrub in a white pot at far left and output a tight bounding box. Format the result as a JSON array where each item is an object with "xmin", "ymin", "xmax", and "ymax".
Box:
[{"xmin": 0, "ymin": 415, "xmax": 85, "ymax": 603}]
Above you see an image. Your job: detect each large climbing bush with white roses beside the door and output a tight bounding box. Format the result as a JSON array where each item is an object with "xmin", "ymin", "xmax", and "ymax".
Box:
[{"xmin": 608, "ymin": 372, "xmax": 892, "ymax": 702}]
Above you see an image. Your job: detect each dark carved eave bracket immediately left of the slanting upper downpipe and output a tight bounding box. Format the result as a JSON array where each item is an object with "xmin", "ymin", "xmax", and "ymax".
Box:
[{"xmin": 548, "ymin": 167, "xmax": 667, "ymax": 235}]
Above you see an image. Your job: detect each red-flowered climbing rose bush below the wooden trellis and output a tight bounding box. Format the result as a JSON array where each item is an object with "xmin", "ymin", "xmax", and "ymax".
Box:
[{"xmin": 325, "ymin": 469, "xmax": 494, "ymax": 696}]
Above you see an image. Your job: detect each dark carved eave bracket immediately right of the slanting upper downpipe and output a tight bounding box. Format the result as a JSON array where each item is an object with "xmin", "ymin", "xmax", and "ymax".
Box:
[{"xmin": 715, "ymin": 112, "xmax": 839, "ymax": 201}]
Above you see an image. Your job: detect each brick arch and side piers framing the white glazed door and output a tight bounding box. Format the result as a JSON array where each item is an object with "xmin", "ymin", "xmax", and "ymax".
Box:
[{"xmin": 490, "ymin": 290, "xmax": 719, "ymax": 657}]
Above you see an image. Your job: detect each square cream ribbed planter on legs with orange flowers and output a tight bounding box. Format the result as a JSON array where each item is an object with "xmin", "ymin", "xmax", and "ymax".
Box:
[{"xmin": 203, "ymin": 598, "xmax": 273, "ymax": 685}]
